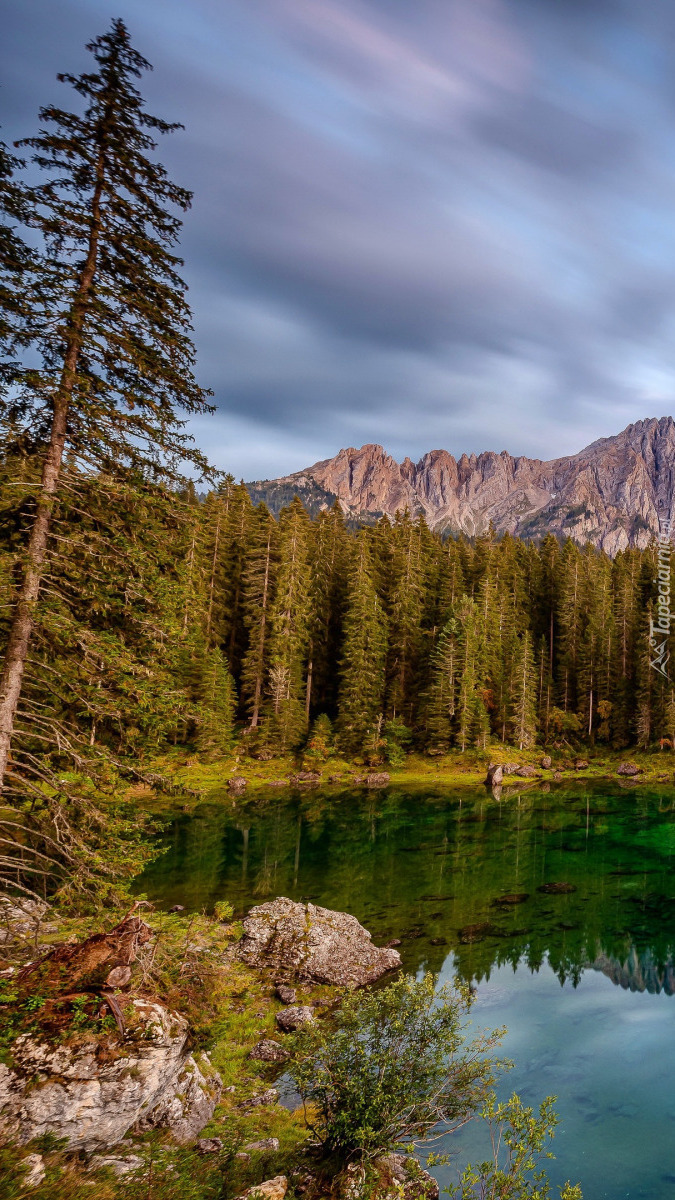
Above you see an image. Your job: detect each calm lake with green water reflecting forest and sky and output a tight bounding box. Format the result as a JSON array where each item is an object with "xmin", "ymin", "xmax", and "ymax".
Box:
[{"xmin": 132, "ymin": 785, "xmax": 675, "ymax": 1200}]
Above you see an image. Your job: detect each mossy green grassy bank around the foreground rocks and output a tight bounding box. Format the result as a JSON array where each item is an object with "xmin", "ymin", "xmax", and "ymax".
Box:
[{"xmin": 0, "ymin": 910, "xmax": 334, "ymax": 1200}]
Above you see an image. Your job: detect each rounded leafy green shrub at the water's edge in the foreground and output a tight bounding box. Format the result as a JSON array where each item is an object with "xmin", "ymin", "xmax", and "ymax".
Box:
[{"xmin": 289, "ymin": 974, "xmax": 501, "ymax": 1159}]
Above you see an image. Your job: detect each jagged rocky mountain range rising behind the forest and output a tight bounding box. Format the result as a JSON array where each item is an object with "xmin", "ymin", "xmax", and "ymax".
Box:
[{"xmin": 246, "ymin": 416, "xmax": 675, "ymax": 554}]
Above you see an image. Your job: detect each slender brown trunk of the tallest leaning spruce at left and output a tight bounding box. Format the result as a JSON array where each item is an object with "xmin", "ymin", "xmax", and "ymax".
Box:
[{"xmin": 0, "ymin": 144, "xmax": 104, "ymax": 791}]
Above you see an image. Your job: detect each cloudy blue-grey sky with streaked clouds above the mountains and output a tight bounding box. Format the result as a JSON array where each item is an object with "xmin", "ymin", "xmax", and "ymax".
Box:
[{"xmin": 0, "ymin": 0, "xmax": 675, "ymax": 479}]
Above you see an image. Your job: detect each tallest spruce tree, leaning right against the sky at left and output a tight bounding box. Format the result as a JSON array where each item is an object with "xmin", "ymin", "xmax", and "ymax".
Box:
[{"xmin": 0, "ymin": 20, "xmax": 207, "ymax": 781}]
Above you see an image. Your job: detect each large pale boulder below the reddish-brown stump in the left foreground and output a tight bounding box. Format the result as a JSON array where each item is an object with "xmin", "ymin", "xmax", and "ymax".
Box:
[{"xmin": 0, "ymin": 998, "xmax": 221, "ymax": 1153}]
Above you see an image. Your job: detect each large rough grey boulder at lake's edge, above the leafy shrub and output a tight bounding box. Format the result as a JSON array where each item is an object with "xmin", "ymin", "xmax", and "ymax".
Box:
[{"xmin": 239, "ymin": 896, "xmax": 401, "ymax": 988}]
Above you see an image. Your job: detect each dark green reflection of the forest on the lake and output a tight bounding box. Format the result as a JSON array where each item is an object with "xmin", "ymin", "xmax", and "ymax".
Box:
[{"xmin": 137, "ymin": 784, "xmax": 675, "ymax": 995}]
